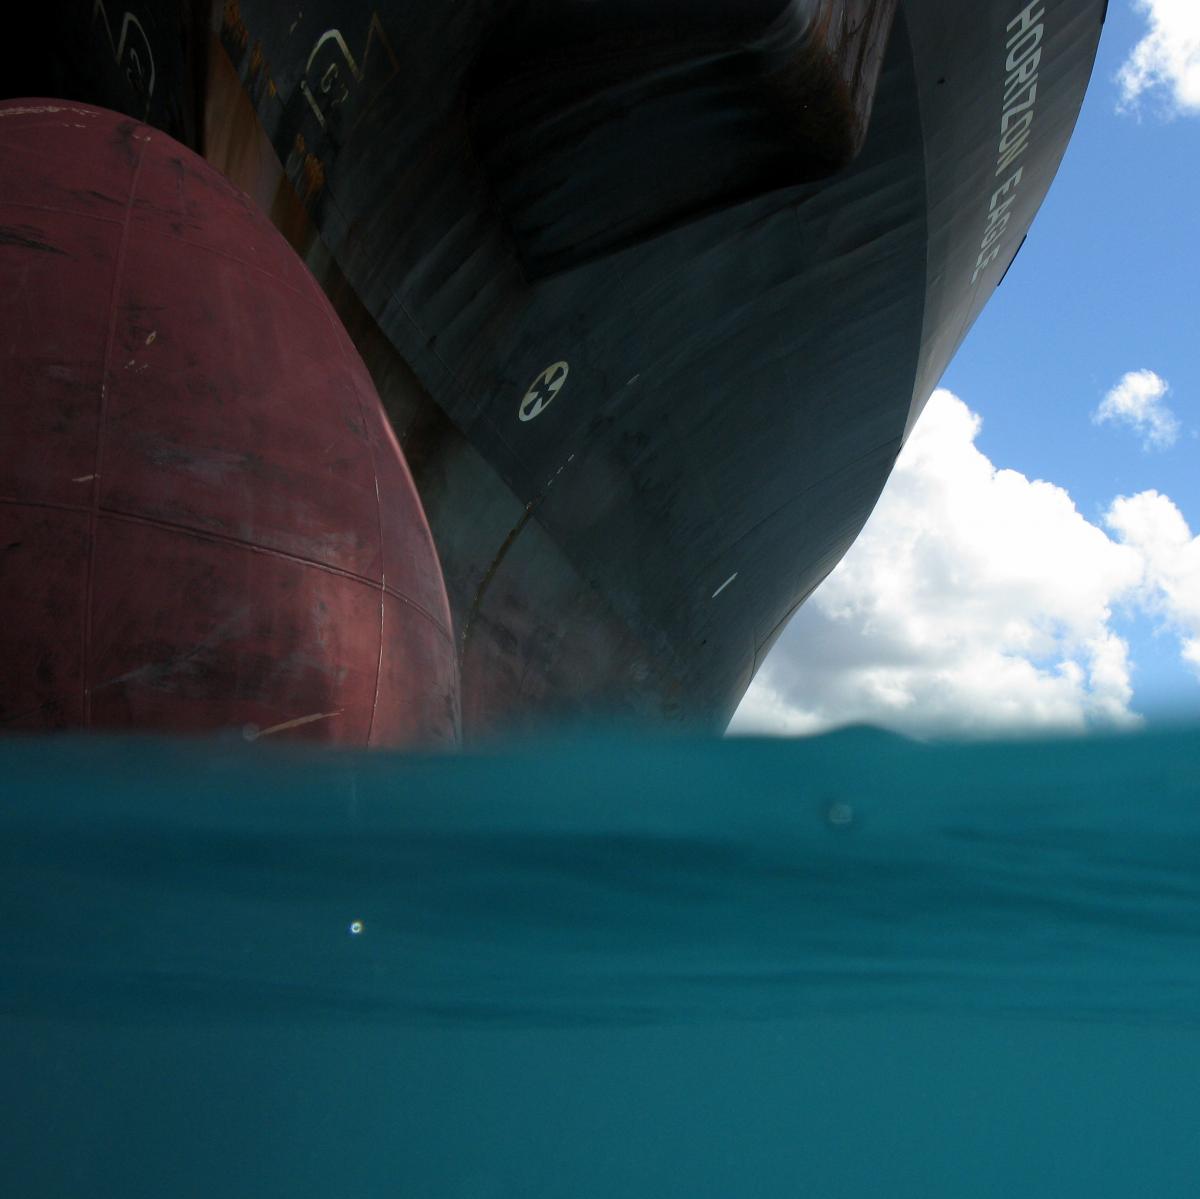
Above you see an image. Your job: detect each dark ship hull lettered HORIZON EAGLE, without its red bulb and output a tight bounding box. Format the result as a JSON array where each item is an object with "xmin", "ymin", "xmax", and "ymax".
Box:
[{"xmin": 0, "ymin": 0, "xmax": 1106, "ymax": 741}]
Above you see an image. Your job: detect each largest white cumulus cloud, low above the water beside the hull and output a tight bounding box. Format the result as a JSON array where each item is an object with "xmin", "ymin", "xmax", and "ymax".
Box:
[{"xmin": 731, "ymin": 390, "xmax": 1161, "ymax": 735}]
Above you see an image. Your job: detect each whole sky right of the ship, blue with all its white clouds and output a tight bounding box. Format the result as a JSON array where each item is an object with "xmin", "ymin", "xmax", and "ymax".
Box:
[{"xmin": 732, "ymin": 0, "xmax": 1200, "ymax": 735}]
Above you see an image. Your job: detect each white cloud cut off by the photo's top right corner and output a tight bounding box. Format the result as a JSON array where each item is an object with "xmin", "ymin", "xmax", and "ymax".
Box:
[{"xmin": 1117, "ymin": 0, "xmax": 1200, "ymax": 115}]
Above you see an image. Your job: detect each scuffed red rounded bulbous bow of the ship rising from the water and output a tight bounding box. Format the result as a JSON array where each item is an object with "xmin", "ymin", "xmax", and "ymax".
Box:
[{"xmin": 0, "ymin": 100, "xmax": 458, "ymax": 745}]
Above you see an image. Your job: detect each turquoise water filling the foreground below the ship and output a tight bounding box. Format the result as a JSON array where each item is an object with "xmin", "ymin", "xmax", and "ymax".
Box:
[{"xmin": 0, "ymin": 730, "xmax": 1200, "ymax": 1199}]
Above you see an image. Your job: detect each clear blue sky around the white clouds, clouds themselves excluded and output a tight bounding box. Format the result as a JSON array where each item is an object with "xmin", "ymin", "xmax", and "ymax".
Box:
[{"xmin": 942, "ymin": 0, "xmax": 1200, "ymax": 714}]
